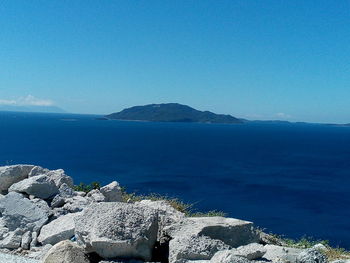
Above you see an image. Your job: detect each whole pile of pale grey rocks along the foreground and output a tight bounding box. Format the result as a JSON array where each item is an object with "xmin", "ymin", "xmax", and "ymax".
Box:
[{"xmin": 0, "ymin": 165, "xmax": 350, "ymax": 263}]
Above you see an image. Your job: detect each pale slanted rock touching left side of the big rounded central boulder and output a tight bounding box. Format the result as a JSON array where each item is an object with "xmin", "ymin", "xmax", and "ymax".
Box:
[{"xmin": 38, "ymin": 213, "xmax": 80, "ymax": 245}]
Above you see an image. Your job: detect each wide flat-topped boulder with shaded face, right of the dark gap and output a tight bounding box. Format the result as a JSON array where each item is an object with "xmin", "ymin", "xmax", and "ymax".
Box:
[{"xmin": 163, "ymin": 217, "xmax": 259, "ymax": 262}]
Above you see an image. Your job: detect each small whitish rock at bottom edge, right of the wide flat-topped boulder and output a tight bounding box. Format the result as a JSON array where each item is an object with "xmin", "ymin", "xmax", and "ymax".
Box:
[{"xmin": 263, "ymin": 245, "xmax": 302, "ymax": 263}]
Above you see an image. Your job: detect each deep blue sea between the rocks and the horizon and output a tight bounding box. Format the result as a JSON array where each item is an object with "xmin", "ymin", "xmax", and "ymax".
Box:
[{"xmin": 0, "ymin": 112, "xmax": 350, "ymax": 248}]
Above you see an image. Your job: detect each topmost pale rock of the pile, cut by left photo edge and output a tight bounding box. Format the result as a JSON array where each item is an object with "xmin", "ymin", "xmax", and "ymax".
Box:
[{"xmin": 0, "ymin": 165, "xmax": 34, "ymax": 194}]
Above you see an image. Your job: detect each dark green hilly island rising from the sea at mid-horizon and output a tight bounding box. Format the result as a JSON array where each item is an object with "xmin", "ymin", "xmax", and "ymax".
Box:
[{"xmin": 105, "ymin": 103, "xmax": 243, "ymax": 124}]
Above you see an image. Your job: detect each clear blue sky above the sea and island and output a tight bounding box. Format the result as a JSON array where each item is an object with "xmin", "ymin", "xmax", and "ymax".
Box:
[{"xmin": 0, "ymin": 0, "xmax": 350, "ymax": 123}]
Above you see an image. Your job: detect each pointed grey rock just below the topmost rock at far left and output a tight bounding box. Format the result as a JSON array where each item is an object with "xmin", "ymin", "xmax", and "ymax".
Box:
[{"xmin": 9, "ymin": 175, "xmax": 58, "ymax": 199}]
